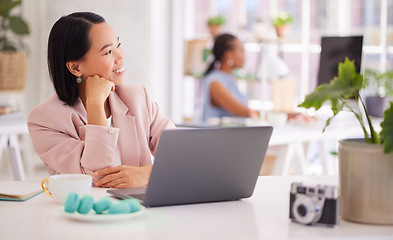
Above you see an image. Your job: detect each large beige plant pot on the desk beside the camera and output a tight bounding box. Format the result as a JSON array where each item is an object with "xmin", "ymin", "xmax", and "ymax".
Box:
[{"xmin": 338, "ymin": 139, "xmax": 393, "ymax": 224}]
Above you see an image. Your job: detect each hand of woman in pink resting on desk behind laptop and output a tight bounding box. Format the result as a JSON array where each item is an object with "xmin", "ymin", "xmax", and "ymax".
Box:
[{"xmin": 94, "ymin": 165, "xmax": 152, "ymax": 188}]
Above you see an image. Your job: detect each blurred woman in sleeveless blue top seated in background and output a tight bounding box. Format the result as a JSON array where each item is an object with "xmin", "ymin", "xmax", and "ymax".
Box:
[{"xmin": 202, "ymin": 34, "xmax": 259, "ymax": 123}]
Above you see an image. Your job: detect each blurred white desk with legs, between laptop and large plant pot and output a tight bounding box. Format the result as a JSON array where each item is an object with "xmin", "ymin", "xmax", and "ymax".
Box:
[{"xmin": 269, "ymin": 117, "xmax": 366, "ymax": 175}]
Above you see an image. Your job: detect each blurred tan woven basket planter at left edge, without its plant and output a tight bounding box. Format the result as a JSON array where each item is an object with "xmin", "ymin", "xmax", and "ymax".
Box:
[{"xmin": 0, "ymin": 51, "xmax": 27, "ymax": 91}]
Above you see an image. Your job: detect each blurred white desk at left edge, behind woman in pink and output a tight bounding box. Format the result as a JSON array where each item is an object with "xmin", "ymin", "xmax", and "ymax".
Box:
[{"xmin": 0, "ymin": 121, "xmax": 29, "ymax": 181}]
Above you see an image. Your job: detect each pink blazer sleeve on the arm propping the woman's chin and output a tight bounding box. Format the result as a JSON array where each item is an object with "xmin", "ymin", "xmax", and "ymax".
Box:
[{"xmin": 28, "ymin": 107, "xmax": 119, "ymax": 175}]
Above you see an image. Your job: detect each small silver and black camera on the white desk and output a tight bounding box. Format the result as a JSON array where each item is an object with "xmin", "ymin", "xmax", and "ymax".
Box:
[{"xmin": 289, "ymin": 183, "xmax": 340, "ymax": 225}]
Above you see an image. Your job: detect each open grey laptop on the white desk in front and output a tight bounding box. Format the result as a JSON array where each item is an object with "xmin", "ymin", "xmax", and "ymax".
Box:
[{"xmin": 107, "ymin": 126, "xmax": 273, "ymax": 207}]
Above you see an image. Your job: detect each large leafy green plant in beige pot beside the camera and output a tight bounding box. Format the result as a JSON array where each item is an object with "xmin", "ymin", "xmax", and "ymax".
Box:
[{"xmin": 299, "ymin": 59, "xmax": 393, "ymax": 224}]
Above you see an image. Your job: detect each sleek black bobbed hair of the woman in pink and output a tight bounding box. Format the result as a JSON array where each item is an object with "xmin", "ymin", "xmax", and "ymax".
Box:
[{"xmin": 48, "ymin": 12, "xmax": 105, "ymax": 106}]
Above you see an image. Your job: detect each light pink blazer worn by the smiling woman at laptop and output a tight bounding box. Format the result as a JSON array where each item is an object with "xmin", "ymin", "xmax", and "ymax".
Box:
[{"xmin": 27, "ymin": 84, "xmax": 174, "ymax": 175}]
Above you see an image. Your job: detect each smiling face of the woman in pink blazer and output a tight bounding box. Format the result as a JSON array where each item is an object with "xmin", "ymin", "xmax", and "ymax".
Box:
[{"xmin": 79, "ymin": 23, "xmax": 125, "ymax": 85}]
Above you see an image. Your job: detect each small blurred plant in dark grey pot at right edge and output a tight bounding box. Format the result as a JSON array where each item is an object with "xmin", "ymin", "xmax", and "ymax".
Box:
[{"xmin": 364, "ymin": 68, "xmax": 393, "ymax": 118}]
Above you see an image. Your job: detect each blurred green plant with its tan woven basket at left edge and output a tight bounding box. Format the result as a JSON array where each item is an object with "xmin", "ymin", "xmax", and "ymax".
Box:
[{"xmin": 0, "ymin": 0, "xmax": 29, "ymax": 90}]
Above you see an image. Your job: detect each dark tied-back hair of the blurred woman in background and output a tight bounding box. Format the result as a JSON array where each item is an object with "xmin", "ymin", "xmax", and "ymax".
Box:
[{"xmin": 205, "ymin": 33, "xmax": 237, "ymax": 76}]
